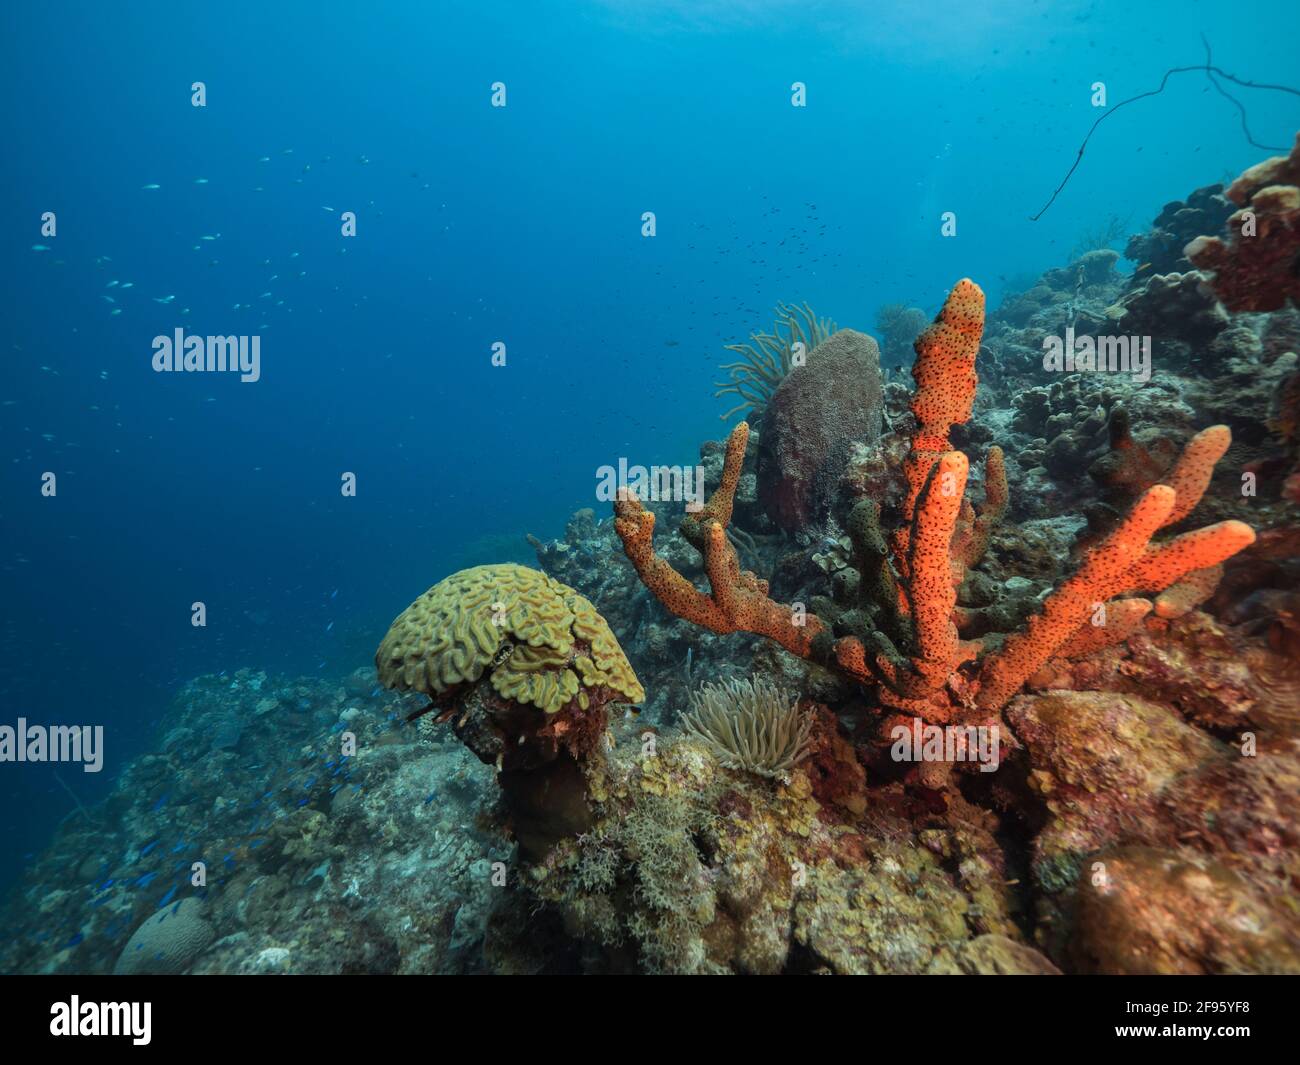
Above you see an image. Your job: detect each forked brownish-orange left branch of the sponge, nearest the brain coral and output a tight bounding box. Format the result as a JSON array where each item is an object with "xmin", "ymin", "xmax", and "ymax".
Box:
[{"xmin": 614, "ymin": 421, "xmax": 823, "ymax": 658}]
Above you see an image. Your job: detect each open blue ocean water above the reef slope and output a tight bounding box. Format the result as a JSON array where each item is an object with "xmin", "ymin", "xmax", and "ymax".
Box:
[{"xmin": 0, "ymin": 0, "xmax": 1300, "ymax": 878}]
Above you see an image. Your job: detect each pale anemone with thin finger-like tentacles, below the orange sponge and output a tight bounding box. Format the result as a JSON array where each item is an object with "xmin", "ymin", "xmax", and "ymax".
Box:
[{"xmin": 681, "ymin": 680, "xmax": 813, "ymax": 776}]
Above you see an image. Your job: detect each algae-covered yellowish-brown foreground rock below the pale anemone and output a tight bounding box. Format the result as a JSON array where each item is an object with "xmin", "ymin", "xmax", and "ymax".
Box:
[{"xmin": 530, "ymin": 713, "xmax": 1035, "ymax": 974}]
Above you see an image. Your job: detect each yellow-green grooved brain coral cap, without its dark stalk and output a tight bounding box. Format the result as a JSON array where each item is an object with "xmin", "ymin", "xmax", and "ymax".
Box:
[{"xmin": 374, "ymin": 564, "xmax": 645, "ymax": 714}]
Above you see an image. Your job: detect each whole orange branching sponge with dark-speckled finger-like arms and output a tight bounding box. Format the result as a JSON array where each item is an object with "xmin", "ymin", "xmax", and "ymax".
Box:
[{"xmin": 615, "ymin": 280, "xmax": 1255, "ymax": 723}]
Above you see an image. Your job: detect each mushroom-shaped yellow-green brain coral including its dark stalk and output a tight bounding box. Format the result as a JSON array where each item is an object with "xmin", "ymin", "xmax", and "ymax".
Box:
[{"xmin": 374, "ymin": 564, "xmax": 645, "ymax": 858}]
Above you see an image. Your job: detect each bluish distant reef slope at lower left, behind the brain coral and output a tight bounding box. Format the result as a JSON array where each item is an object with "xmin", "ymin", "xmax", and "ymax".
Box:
[{"xmin": 0, "ymin": 668, "xmax": 512, "ymax": 974}]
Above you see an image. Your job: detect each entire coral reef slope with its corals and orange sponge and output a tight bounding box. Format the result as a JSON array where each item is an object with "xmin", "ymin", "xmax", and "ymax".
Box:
[{"xmin": 0, "ymin": 145, "xmax": 1300, "ymax": 974}]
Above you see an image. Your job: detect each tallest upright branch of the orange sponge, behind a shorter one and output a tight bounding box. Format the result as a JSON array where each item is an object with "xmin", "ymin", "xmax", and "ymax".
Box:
[{"xmin": 893, "ymin": 277, "xmax": 984, "ymax": 573}]
